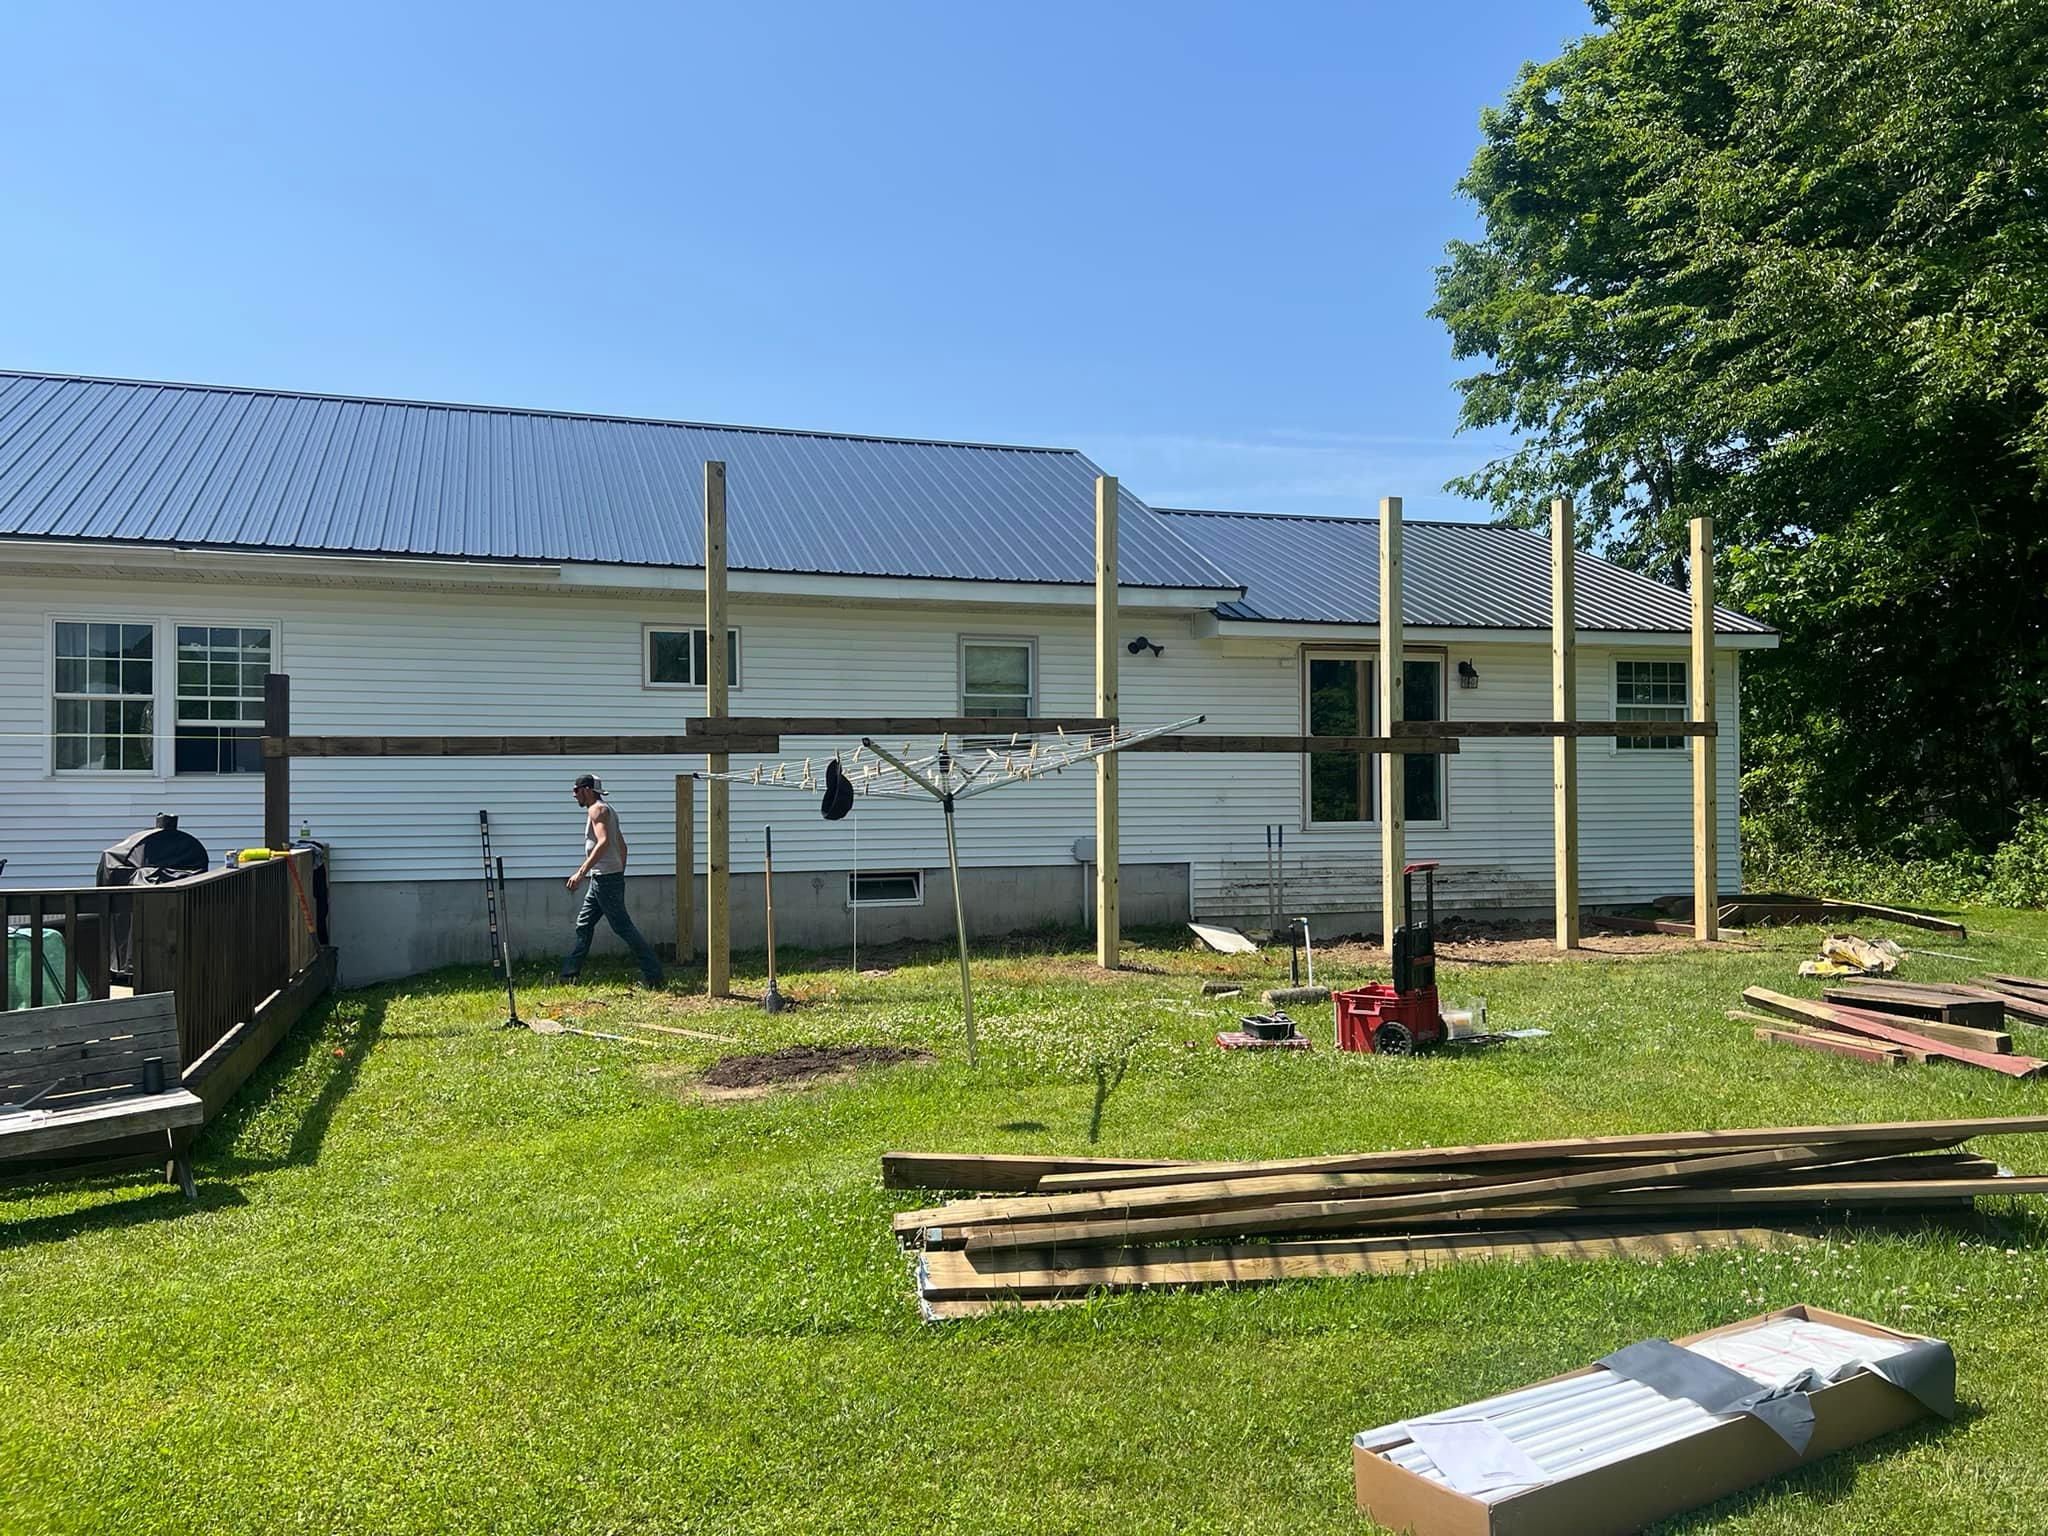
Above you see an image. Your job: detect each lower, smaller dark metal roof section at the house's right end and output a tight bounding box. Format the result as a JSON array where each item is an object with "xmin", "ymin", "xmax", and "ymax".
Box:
[{"xmin": 1159, "ymin": 508, "xmax": 1774, "ymax": 635}]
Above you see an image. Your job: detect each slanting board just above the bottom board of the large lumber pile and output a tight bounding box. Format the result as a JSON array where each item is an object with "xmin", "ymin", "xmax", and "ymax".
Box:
[{"xmin": 938, "ymin": 1147, "xmax": 1867, "ymax": 1249}]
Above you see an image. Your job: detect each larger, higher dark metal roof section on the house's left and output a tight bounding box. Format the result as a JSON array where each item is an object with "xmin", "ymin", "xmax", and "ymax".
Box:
[{"xmin": 0, "ymin": 371, "xmax": 1239, "ymax": 592}]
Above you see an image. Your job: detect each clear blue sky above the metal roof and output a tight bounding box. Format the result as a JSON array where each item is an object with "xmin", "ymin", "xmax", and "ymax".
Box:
[{"xmin": 0, "ymin": 0, "xmax": 1589, "ymax": 516}]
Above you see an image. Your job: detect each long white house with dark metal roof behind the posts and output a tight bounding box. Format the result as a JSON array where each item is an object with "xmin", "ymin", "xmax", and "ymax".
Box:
[{"xmin": 0, "ymin": 373, "xmax": 1776, "ymax": 981}]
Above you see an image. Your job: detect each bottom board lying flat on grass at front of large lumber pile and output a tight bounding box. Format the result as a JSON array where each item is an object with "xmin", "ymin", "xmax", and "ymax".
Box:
[{"xmin": 918, "ymin": 1223, "xmax": 1810, "ymax": 1300}]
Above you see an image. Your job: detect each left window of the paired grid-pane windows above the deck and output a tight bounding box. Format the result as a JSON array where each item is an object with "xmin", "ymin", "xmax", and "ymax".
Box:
[{"xmin": 49, "ymin": 618, "xmax": 156, "ymax": 774}]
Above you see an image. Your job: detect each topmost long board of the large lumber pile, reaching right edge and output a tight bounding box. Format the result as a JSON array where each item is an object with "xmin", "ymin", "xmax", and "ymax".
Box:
[{"xmin": 1032, "ymin": 1114, "xmax": 2048, "ymax": 1194}]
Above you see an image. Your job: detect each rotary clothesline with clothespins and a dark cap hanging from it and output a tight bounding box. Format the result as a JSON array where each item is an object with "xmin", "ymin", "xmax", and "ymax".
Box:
[{"xmin": 694, "ymin": 715, "xmax": 1206, "ymax": 1067}]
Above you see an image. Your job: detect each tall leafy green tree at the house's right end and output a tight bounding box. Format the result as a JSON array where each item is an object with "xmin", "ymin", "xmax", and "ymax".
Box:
[{"xmin": 1434, "ymin": 0, "xmax": 2048, "ymax": 854}]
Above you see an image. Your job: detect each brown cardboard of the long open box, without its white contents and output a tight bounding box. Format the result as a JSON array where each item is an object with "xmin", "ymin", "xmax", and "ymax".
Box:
[{"xmin": 1352, "ymin": 1307, "xmax": 1929, "ymax": 1536}]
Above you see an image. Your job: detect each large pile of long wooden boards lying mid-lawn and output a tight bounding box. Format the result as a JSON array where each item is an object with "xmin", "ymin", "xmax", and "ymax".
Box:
[{"xmin": 883, "ymin": 1116, "xmax": 2048, "ymax": 1317}]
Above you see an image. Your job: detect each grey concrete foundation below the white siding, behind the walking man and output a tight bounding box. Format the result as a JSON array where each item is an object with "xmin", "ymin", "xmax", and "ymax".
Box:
[{"xmin": 332, "ymin": 864, "xmax": 1188, "ymax": 987}]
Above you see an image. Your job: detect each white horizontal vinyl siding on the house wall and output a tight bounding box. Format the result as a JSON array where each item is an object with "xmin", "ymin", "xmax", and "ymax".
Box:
[{"xmin": 0, "ymin": 575, "xmax": 1739, "ymax": 915}]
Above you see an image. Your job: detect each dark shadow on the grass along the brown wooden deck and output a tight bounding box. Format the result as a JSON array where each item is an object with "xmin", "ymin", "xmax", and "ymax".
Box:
[{"xmin": 195, "ymin": 993, "xmax": 387, "ymax": 1176}]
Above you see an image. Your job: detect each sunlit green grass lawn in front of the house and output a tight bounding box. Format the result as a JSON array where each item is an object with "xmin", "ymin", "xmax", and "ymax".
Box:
[{"xmin": 0, "ymin": 911, "xmax": 2048, "ymax": 1536}]
